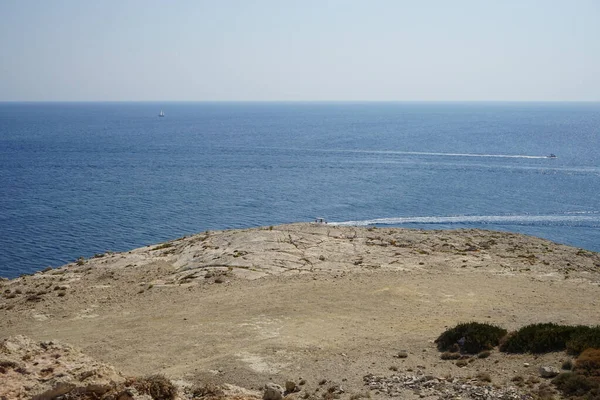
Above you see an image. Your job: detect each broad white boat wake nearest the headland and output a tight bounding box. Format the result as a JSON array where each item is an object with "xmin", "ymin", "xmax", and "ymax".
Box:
[{"xmin": 330, "ymin": 211, "xmax": 600, "ymax": 227}]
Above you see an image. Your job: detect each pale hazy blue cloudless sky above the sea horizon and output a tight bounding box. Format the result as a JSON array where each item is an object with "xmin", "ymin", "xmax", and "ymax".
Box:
[{"xmin": 0, "ymin": 0, "xmax": 600, "ymax": 101}]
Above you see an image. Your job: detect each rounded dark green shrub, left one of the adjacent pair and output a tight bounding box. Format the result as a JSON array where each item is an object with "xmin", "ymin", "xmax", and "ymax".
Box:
[{"xmin": 435, "ymin": 322, "xmax": 506, "ymax": 354}]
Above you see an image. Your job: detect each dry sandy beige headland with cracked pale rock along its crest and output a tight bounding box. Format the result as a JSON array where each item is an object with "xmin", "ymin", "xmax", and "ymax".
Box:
[{"xmin": 0, "ymin": 224, "xmax": 600, "ymax": 397}]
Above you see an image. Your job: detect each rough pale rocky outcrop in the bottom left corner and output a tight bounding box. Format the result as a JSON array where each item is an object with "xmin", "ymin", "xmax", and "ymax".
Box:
[{"xmin": 0, "ymin": 336, "xmax": 266, "ymax": 400}]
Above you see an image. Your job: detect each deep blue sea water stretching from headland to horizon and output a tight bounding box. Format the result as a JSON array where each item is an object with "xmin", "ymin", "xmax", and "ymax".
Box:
[{"xmin": 0, "ymin": 103, "xmax": 600, "ymax": 277}]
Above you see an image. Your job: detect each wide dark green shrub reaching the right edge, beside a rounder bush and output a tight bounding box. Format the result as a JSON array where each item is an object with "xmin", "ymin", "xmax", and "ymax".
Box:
[{"xmin": 500, "ymin": 323, "xmax": 600, "ymax": 353}]
